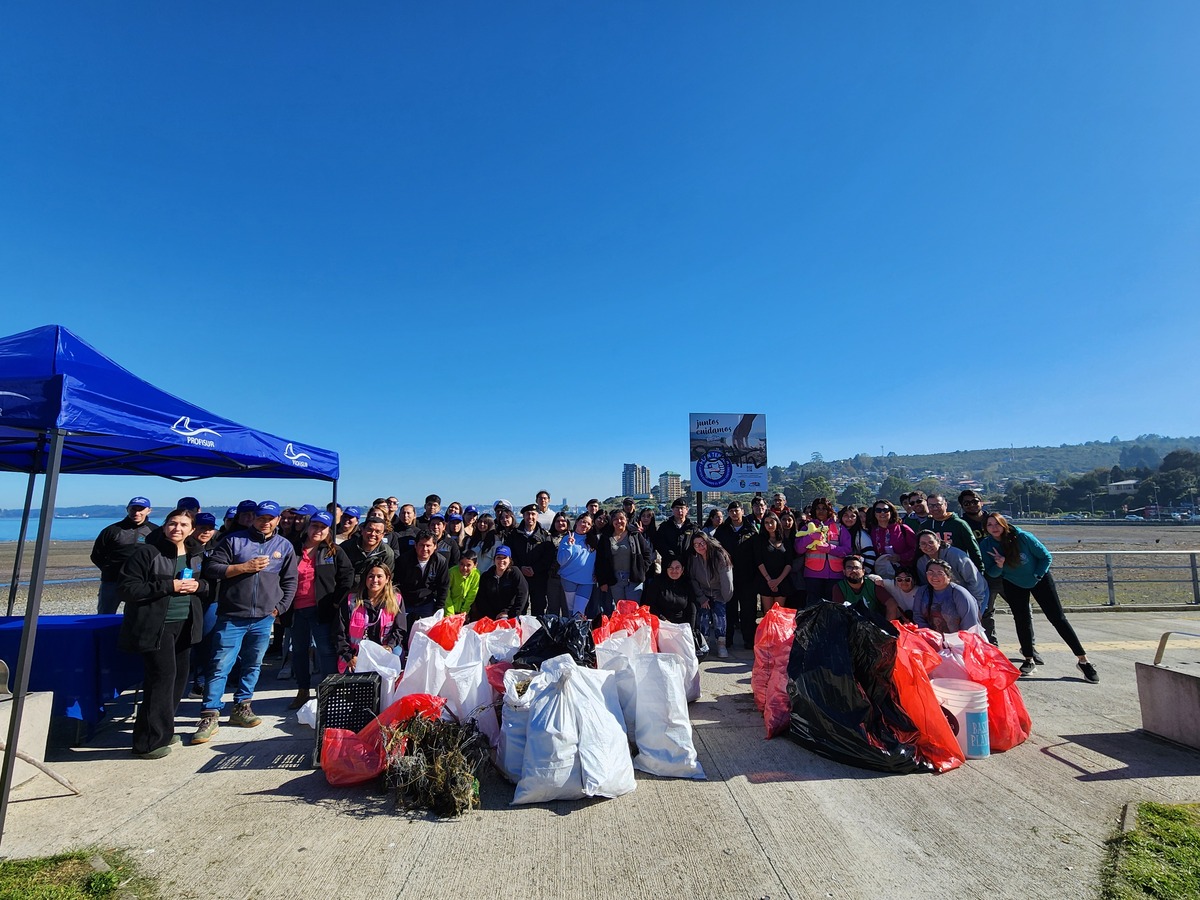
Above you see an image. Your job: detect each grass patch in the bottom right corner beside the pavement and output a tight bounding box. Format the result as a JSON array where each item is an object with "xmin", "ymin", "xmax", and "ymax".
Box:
[{"xmin": 1102, "ymin": 803, "xmax": 1200, "ymax": 900}]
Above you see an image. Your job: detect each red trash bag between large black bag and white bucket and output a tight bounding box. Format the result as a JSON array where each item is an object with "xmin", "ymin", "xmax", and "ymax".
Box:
[{"xmin": 892, "ymin": 624, "xmax": 962, "ymax": 772}]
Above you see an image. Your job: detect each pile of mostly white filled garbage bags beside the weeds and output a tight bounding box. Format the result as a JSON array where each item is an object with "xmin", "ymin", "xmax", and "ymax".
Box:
[{"xmin": 323, "ymin": 601, "xmax": 704, "ymax": 803}]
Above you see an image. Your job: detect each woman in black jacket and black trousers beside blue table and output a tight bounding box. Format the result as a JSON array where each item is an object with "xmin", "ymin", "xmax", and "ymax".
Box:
[{"xmin": 118, "ymin": 509, "xmax": 209, "ymax": 760}]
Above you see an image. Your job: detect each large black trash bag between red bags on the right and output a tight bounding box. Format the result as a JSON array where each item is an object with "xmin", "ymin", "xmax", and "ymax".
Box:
[{"xmin": 787, "ymin": 602, "xmax": 934, "ymax": 774}]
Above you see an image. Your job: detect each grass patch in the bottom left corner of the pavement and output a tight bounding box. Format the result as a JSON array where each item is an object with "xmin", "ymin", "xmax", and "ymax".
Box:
[{"xmin": 0, "ymin": 850, "xmax": 157, "ymax": 900}]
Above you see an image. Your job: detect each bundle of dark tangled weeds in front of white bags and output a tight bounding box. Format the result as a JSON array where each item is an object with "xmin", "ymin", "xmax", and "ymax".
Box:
[{"xmin": 383, "ymin": 715, "xmax": 488, "ymax": 816}]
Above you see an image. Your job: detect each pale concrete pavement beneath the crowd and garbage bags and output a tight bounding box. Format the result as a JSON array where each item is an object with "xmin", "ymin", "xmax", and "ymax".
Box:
[{"xmin": 4, "ymin": 612, "xmax": 1200, "ymax": 900}]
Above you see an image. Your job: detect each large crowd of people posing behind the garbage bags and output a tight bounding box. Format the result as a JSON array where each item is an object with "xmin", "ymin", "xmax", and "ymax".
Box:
[{"xmin": 91, "ymin": 491, "xmax": 1099, "ymax": 758}]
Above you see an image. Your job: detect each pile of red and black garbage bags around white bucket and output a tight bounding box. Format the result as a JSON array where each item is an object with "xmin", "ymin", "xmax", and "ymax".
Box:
[{"xmin": 751, "ymin": 604, "xmax": 1031, "ymax": 773}]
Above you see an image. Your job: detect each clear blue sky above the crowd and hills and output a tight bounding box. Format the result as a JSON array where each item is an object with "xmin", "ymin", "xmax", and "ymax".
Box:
[{"xmin": 0, "ymin": 0, "xmax": 1200, "ymax": 506}]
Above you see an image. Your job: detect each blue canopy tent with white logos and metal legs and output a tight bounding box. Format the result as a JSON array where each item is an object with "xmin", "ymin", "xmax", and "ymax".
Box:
[{"xmin": 0, "ymin": 325, "xmax": 338, "ymax": 841}]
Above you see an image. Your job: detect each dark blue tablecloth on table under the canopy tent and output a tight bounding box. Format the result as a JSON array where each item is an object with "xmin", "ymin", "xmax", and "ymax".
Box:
[{"xmin": 0, "ymin": 616, "xmax": 143, "ymax": 725}]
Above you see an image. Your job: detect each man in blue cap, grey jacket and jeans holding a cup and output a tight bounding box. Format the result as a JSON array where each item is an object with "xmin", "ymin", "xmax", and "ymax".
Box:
[{"xmin": 192, "ymin": 500, "xmax": 296, "ymax": 744}]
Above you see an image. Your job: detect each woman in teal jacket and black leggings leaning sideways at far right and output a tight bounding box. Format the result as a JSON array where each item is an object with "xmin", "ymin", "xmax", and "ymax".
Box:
[{"xmin": 980, "ymin": 512, "xmax": 1100, "ymax": 684}]
